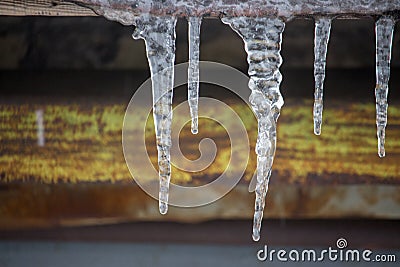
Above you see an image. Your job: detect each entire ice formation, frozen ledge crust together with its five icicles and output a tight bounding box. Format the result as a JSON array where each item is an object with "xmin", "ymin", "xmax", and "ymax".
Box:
[{"xmin": 96, "ymin": 0, "xmax": 400, "ymax": 241}]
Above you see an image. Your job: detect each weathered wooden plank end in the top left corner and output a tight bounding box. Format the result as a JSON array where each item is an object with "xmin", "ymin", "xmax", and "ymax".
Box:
[{"xmin": 0, "ymin": 0, "xmax": 97, "ymax": 16}]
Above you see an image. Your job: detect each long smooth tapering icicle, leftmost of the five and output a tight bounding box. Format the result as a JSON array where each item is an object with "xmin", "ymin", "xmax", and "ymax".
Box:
[{"xmin": 132, "ymin": 15, "xmax": 176, "ymax": 214}]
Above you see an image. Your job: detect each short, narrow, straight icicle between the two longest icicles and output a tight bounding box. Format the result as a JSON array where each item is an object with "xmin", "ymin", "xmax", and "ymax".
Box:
[{"xmin": 188, "ymin": 17, "xmax": 202, "ymax": 134}]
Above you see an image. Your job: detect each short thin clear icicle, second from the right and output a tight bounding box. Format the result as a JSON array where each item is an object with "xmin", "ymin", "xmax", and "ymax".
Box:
[{"xmin": 313, "ymin": 18, "xmax": 332, "ymax": 135}]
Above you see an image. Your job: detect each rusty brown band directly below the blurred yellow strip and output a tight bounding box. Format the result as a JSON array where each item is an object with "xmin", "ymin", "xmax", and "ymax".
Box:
[{"xmin": 0, "ymin": 182, "xmax": 400, "ymax": 230}]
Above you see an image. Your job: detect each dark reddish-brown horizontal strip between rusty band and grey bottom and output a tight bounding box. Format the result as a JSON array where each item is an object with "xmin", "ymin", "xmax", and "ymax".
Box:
[{"xmin": 0, "ymin": 219, "xmax": 400, "ymax": 249}]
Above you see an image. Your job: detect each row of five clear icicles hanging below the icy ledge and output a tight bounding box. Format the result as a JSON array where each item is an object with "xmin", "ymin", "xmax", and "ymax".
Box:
[{"xmin": 133, "ymin": 12, "xmax": 395, "ymax": 241}]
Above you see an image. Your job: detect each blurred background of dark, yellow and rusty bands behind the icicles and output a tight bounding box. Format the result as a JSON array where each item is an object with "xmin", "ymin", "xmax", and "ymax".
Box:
[{"xmin": 0, "ymin": 16, "xmax": 400, "ymax": 266}]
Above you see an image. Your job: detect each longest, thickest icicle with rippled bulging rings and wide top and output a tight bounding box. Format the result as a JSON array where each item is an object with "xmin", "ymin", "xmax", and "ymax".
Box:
[{"xmin": 222, "ymin": 17, "xmax": 285, "ymax": 241}]
